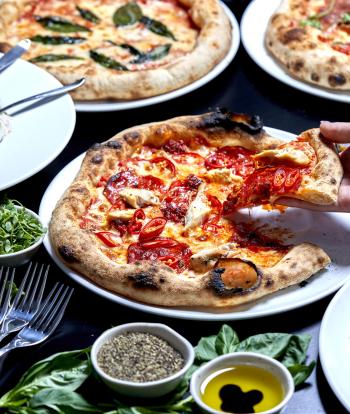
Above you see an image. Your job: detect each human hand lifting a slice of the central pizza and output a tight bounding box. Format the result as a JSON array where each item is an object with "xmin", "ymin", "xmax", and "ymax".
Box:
[{"xmin": 276, "ymin": 121, "xmax": 350, "ymax": 213}]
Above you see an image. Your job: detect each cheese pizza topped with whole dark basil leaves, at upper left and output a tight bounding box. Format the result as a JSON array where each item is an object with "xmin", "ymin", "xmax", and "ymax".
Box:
[{"xmin": 0, "ymin": 0, "xmax": 231, "ymax": 100}]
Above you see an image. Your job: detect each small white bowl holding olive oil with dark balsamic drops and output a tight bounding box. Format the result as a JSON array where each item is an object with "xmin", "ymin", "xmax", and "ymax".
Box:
[{"xmin": 190, "ymin": 352, "xmax": 294, "ymax": 414}]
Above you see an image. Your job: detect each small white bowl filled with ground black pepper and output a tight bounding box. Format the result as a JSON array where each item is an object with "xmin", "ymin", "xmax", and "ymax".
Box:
[{"xmin": 91, "ymin": 322, "xmax": 194, "ymax": 398}]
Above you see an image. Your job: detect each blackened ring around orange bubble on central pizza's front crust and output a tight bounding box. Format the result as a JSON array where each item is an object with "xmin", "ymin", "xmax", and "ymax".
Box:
[{"xmin": 208, "ymin": 259, "xmax": 262, "ymax": 297}]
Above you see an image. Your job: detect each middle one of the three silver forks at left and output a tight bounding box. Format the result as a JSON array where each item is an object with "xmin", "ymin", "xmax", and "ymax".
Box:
[{"xmin": 0, "ymin": 263, "xmax": 50, "ymax": 341}]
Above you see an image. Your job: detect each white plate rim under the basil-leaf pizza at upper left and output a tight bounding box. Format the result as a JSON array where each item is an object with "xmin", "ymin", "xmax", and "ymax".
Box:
[{"xmin": 75, "ymin": 4, "xmax": 240, "ymax": 112}]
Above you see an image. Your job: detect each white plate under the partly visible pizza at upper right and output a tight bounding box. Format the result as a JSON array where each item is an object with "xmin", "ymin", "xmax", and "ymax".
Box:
[{"xmin": 241, "ymin": 0, "xmax": 350, "ymax": 103}]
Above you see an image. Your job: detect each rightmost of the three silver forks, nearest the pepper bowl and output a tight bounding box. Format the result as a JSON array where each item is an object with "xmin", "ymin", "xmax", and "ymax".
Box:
[{"xmin": 0, "ymin": 283, "xmax": 74, "ymax": 357}]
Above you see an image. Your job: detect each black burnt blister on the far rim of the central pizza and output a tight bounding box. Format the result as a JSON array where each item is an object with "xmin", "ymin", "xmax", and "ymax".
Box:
[{"xmin": 194, "ymin": 108, "xmax": 263, "ymax": 134}]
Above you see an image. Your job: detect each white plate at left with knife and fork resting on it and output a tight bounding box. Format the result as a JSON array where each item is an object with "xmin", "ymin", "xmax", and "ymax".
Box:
[{"xmin": 0, "ymin": 60, "xmax": 75, "ymax": 190}]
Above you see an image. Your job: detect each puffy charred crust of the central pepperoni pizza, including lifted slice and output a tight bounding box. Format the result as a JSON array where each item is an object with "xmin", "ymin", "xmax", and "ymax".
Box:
[{"xmin": 50, "ymin": 111, "xmax": 341, "ymax": 307}]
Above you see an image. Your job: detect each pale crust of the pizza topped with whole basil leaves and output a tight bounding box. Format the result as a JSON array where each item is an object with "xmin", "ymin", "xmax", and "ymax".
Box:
[{"xmin": 0, "ymin": 0, "xmax": 232, "ymax": 100}]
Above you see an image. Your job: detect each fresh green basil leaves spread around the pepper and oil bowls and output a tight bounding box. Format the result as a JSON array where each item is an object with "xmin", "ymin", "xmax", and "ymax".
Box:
[{"xmin": 0, "ymin": 325, "xmax": 315, "ymax": 414}]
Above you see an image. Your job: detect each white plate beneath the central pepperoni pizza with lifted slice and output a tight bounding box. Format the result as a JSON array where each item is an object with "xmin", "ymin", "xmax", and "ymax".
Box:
[{"xmin": 39, "ymin": 128, "xmax": 350, "ymax": 320}]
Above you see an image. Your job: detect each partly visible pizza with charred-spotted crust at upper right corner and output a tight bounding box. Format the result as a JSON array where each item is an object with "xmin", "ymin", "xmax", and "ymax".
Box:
[{"xmin": 265, "ymin": 0, "xmax": 350, "ymax": 89}]
